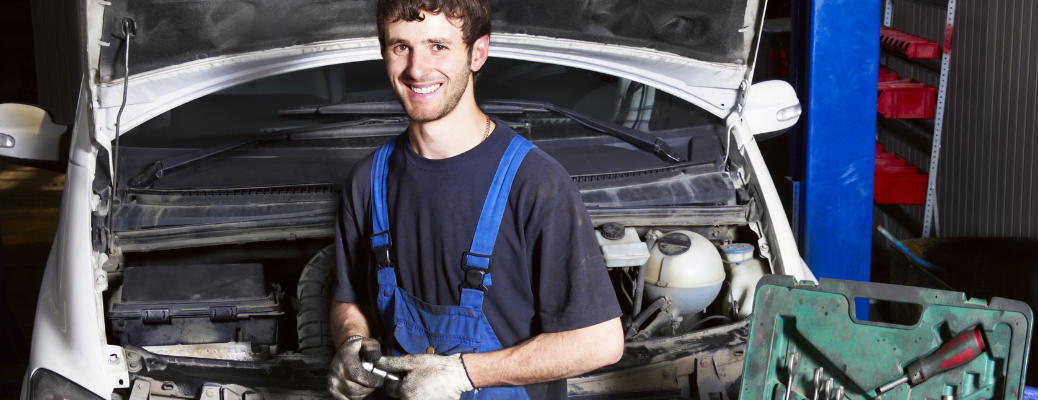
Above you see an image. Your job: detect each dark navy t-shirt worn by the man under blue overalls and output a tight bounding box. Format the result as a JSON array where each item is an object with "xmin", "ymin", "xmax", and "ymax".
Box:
[{"xmin": 334, "ymin": 123, "xmax": 621, "ymax": 399}]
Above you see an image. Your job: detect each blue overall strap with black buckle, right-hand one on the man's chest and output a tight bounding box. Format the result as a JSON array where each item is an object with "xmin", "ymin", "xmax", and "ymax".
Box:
[{"xmin": 462, "ymin": 135, "xmax": 535, "ymax": 299}]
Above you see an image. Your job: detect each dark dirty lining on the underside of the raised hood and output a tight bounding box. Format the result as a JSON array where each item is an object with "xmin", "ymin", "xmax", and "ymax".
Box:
[{"xmin": 98, "ymin": 0, "xmax": 762, "ymax": 82}]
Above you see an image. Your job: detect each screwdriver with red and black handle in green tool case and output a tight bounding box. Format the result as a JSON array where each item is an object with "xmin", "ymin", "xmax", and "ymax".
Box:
[{"xmin": 876, "ymin": 328, "xmax": 986, "ymax": 394}]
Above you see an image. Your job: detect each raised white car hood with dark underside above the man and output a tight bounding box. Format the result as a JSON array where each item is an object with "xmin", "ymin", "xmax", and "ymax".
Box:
[{"xmin": 82, "ymin": 0, "xmax": 766, "ymax": 141}]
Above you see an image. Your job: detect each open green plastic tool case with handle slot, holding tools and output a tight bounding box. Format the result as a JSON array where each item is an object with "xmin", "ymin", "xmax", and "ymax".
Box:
[{"xmin": 739, "ymin": 275, "xmax": 1033, "ymax": 400}]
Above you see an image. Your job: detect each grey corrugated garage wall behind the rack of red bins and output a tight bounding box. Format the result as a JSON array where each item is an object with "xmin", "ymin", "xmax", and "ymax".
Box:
[{"xmin": 877, "ymin": 0, "xmax": 1038, "ymax": 238}]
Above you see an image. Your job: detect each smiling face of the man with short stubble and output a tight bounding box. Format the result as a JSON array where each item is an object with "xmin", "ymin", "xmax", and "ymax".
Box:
[{"xmin": 382, "ymin": 12, "xmax": 472, "ymax": 123}]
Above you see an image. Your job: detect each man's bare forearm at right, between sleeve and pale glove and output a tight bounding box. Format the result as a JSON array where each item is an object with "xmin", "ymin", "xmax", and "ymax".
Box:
[{"xmin": 464, "ymin": 318, "xmax": 624, "ymax": 388}]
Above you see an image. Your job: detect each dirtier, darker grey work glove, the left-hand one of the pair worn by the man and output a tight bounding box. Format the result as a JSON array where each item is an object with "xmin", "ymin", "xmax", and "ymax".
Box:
[{"xmin": 328, "ymin": 336, "xmax": 383, "ymax": 400}]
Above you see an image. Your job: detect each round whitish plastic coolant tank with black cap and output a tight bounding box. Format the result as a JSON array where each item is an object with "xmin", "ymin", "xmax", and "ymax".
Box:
[{"xmin": 645, "ymin": 231, "xmax": 725, "ymax": 316}]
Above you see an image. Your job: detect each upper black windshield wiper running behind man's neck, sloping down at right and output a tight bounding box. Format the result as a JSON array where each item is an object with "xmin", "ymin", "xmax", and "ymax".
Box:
[{"xmin": 278, "ymin": 100, "xmax": 686, "ymax": 163}]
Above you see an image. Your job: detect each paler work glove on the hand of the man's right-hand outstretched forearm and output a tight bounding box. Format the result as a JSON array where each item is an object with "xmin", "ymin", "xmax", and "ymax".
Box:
[{"xmin": 375, "ymin": 354, "xmax": 473, "ymax": 400}]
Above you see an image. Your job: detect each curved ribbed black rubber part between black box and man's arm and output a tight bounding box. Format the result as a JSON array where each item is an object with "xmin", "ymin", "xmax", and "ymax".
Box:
[{"xmin": 296, "ymin": 245, "xmax": 335, "ymax": 355}]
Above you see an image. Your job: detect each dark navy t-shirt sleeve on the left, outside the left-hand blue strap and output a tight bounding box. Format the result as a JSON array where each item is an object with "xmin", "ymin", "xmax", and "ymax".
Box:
[{"xmin": 332, "ymin": 164, "xmax": 371, "ymax": 304}]
